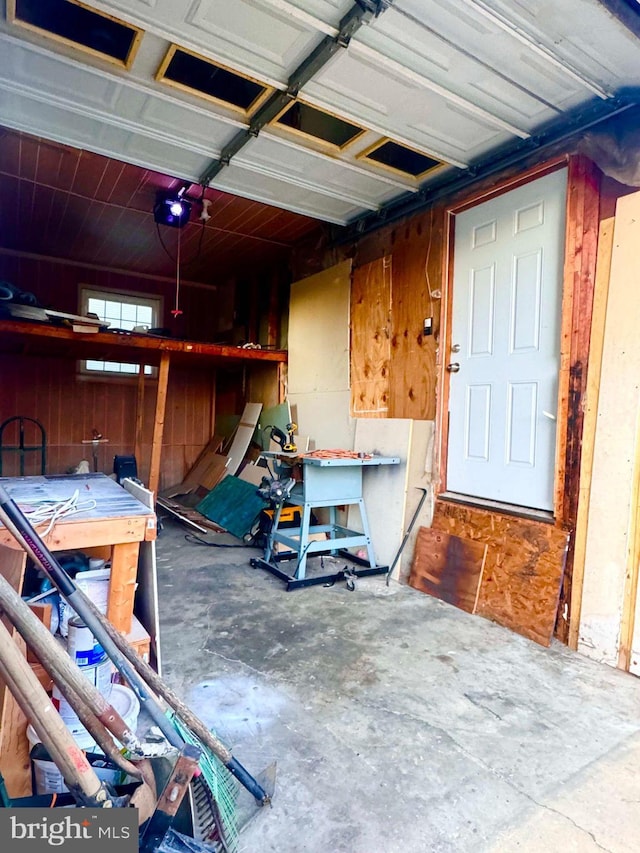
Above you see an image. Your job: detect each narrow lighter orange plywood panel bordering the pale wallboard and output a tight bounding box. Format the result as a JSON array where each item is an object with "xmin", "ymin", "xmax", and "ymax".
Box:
[{"xmin": 351, "ymin": 255, "xmax": 391, "ymax": 418}]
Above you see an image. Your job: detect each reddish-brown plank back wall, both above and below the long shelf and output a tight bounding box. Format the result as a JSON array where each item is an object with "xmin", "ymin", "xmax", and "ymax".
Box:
[{"xmin": 0, "ymin": 252, "xmax": 228, "ymax": 488}]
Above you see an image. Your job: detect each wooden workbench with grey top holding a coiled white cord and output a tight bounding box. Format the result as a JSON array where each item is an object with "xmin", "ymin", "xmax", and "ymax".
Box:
[{"xmin": 0, "ymin": 474, "xmax": 156, "ymax": 797}]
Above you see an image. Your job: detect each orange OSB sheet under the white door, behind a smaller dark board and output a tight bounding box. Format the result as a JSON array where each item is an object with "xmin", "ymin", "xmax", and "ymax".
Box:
[{"xmin": 432, "ymin": 500, "xmax": 569, "ymax": 646}]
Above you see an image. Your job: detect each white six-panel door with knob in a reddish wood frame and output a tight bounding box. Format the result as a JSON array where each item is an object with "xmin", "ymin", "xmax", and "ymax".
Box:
[{"xmin": 447, "ymin": 169, "xmax": 567, "ymax": 510}]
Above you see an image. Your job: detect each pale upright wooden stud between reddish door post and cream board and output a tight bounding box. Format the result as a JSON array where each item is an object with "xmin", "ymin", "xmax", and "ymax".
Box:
[{"xmin": 568, "ymin": 216, "xmax": 615, "ymax": 650}]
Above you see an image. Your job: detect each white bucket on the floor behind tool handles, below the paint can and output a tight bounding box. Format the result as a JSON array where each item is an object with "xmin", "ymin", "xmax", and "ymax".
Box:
[{"xmin": 27, "ymin": 684, "xmax": 140, "ymax": 794}]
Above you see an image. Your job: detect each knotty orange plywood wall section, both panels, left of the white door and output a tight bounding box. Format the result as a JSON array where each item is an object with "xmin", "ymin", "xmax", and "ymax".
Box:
[{"xmin": 351, "ymin": 208, "xmax": 445, "ymax": 420}]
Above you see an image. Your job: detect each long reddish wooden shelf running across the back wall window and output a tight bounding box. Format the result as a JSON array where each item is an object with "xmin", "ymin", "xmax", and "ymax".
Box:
[{"xmin": 0, "ymin": 318, "xmax": 287, "ymax": 367}]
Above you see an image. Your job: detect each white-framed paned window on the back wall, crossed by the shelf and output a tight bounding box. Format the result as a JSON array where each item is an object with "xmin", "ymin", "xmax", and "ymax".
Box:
[{"xmin": 80, "ymin": 288, "xmax": 162, "ymax": 376}]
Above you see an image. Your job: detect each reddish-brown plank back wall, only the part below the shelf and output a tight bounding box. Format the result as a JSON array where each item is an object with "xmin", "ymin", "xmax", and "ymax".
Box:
[{"xmin": 0, "ymin": 355, "xmax": 215, "ymax": 487}]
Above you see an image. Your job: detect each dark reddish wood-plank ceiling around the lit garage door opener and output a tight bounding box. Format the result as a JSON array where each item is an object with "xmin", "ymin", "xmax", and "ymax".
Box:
[{"xmin": 0, "ymin": 128, "xmax": 323, "ymax": 284}]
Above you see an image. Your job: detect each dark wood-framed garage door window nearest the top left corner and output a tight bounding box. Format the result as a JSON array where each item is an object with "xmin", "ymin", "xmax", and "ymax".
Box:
[{"xmin": 7, "ymin": 0, "xmax": 143, "ymax": 68}]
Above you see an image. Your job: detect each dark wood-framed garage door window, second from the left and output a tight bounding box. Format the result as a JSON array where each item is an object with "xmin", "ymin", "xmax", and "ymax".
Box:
[{"xmin": 156, "ymin": 44, "xmax": 272, "ymax": 115}]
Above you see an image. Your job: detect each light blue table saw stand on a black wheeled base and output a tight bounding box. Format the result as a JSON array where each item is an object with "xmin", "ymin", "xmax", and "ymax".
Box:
[{"xmin": 251, "ymin": 451, "xmax": 400, "ymax": 590}]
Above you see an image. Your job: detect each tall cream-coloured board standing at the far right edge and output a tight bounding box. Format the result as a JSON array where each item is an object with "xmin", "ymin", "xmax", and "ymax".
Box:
[{"xmin": 578, "ymin": 192, "xmax": 640, "ymax": 672}]
